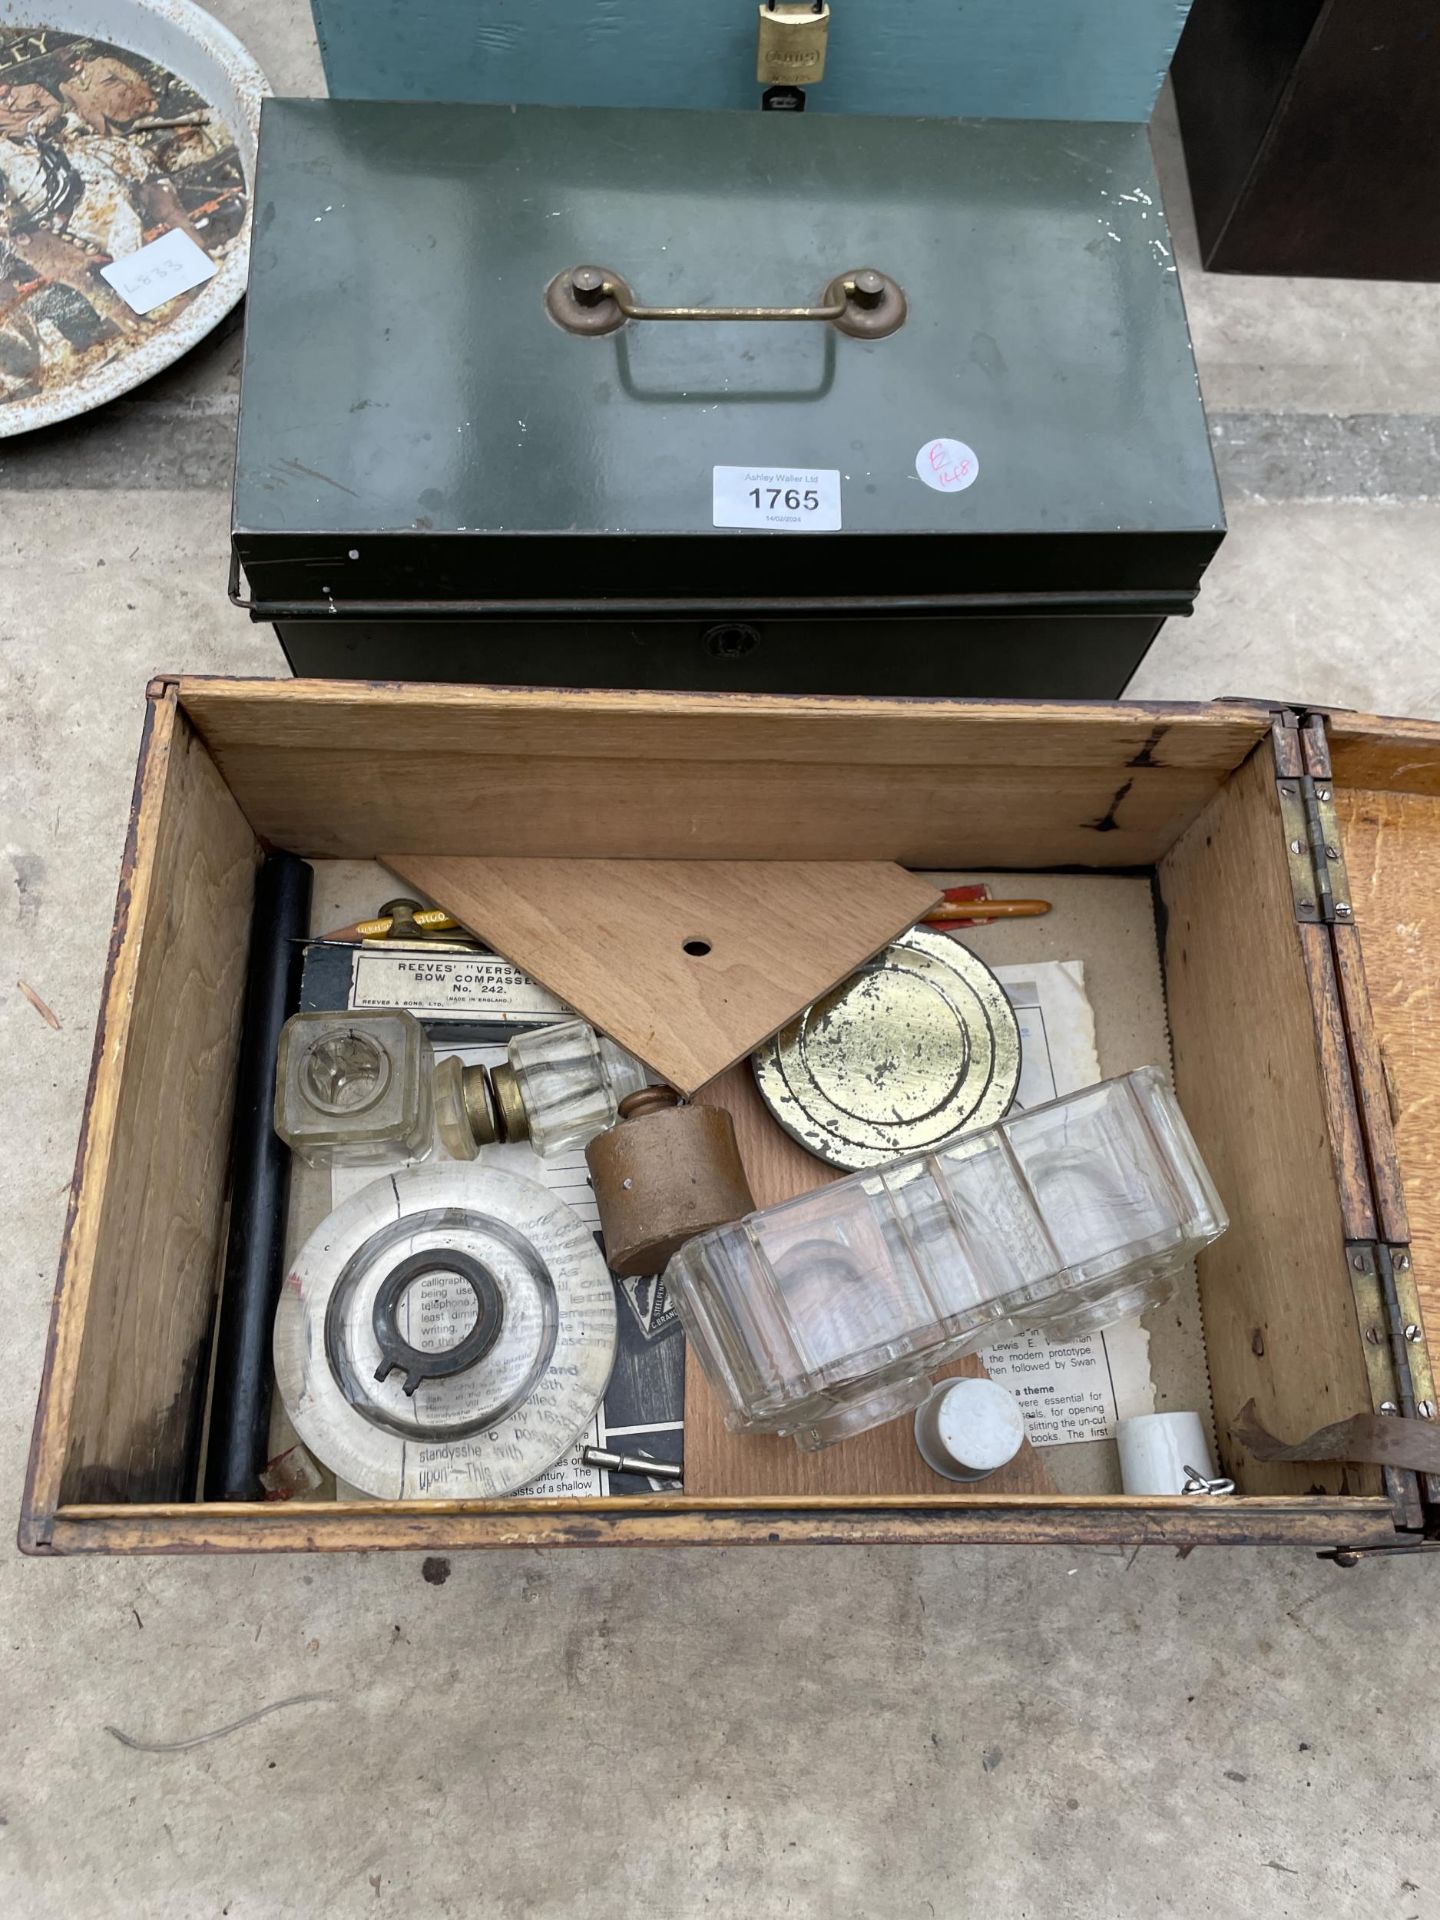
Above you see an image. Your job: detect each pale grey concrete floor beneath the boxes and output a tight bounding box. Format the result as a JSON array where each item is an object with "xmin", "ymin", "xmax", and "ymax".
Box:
[{"xmin": 0, "ymin": 0, "xmax": 1440, "ymax": 1920}]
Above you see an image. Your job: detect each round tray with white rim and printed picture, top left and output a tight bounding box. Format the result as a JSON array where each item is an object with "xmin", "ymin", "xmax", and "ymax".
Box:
[{"xmin": 0, "ymin": 0, "xmax": 269, "ymax": 438}]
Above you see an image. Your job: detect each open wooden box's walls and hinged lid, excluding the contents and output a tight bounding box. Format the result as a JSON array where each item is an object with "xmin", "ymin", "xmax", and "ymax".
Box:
[{"xmin": 19, "ymin": 680, "xmax": 1440, "ymax": 1555}]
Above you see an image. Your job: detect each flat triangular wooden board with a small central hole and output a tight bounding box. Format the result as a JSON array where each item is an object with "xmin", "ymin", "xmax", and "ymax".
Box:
[{"xmin": 380, "ymin": 854, "xmax": 939, "ymax": 1094}]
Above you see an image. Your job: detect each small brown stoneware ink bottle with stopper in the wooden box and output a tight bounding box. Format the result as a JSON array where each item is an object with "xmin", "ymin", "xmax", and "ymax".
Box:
[{"xmin": 586, "ymin": 1087, "xmax": 755, "ymax": 1275}]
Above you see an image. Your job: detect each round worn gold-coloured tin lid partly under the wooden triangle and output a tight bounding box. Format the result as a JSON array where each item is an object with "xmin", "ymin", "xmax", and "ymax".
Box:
[{"xmin": 755, "ymin": 927, "xmax": 1020, "ymax": 1171}]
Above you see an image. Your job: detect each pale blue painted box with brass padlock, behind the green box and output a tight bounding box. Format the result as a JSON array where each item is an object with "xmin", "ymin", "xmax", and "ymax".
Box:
[{"xmin": 311, "ymin": 0, "xmax": 1190, "ymax": 121}]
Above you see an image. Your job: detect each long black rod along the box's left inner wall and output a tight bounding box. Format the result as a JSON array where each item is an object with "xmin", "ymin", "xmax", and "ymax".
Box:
[{"xmin": 205, "ymin": 852, "xmax": 315, "ymax": 1500}]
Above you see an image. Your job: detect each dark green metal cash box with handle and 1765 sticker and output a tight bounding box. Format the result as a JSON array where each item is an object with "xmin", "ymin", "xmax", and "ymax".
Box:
[{"xmin": 232, "ymin": 100, "xmax": 1225, "ymax": 699}]
